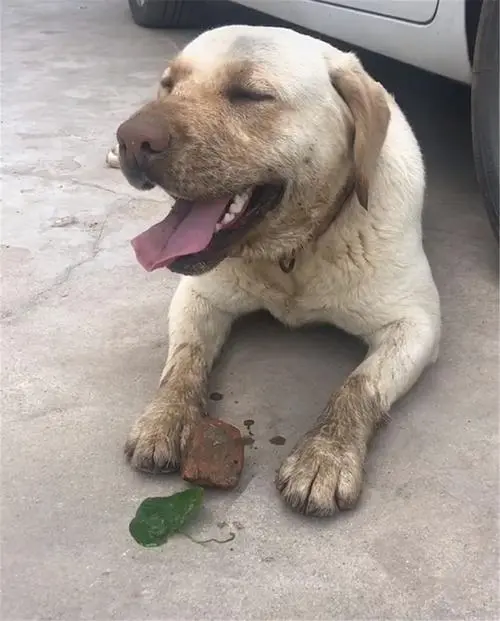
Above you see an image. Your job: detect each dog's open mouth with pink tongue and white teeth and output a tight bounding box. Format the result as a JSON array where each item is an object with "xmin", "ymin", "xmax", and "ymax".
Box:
[{"xmin": 132, "ymin": 185, "xmax": 284, "ymax": 275}]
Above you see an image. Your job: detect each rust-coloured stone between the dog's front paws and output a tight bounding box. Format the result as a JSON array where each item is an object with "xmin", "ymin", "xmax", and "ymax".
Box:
[{"xmin": 181, "ymin": 418, "xmax": 244, "ymax": 489}]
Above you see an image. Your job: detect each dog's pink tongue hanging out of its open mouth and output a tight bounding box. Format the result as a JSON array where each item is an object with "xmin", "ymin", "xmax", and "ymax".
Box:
[{"xmin": 132, "ymin": 196, "xmax": 231, "ymax": 272}]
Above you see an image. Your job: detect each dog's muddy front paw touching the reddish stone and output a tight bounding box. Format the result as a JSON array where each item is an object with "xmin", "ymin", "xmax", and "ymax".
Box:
[{"xmin": 124, "ymin": 406, "xmax": 201, "ymax": 472}]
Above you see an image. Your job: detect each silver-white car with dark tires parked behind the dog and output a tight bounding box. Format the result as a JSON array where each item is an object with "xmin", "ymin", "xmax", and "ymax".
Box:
[{"xmin": 128, "ymin": 0, "xmax": 499, "ymax": 241}]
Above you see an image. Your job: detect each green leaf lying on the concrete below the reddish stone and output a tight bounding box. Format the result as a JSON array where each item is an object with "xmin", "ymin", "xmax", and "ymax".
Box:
[{"xmin": 129, "ymin": 487, "xmax": 203, "ymax": 548}]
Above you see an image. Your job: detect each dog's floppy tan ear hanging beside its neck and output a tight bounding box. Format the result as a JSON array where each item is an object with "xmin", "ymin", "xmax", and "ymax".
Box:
[{"xmin": 329, "ymin": 53, "xmax": 390, "ymax": 209}]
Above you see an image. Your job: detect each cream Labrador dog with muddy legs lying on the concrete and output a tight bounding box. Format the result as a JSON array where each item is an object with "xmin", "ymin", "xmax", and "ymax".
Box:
[{"xmin": 108, "ymin": 26, "xmax": 441, "ymax": 516}]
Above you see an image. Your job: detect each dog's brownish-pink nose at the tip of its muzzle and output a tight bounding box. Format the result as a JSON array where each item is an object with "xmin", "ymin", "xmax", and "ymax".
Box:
[{"xmin": 116, "ymin": 112, "xmax": 170, "ymax": 168}]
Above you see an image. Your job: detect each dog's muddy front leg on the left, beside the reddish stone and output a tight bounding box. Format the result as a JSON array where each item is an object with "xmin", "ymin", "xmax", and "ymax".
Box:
[{"xmin": 125, "ymin": 279, "xmax": 253, "ymax": 472}]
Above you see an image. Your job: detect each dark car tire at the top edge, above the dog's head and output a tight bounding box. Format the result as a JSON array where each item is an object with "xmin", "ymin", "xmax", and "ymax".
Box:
[{"xmin": 128, "ymin": 0, "xmax": 240, "ymax": 28}]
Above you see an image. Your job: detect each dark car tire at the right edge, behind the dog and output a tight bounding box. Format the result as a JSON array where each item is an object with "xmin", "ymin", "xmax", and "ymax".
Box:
[{"xmin": 471, "ymin": 0, "xmax": 499, "ymax": 240}]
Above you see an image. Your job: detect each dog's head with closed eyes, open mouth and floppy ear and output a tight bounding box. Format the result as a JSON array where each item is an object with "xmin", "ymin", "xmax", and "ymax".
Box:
[{"xmin": 117, "ymin": 26, "xmax": 389, "ymax": 274}]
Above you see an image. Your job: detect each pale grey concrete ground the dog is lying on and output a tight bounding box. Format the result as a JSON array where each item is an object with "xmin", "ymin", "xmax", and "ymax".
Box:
[{"xmin": 1, "ymin": 0, "xmax": 499, "ymax": 621}]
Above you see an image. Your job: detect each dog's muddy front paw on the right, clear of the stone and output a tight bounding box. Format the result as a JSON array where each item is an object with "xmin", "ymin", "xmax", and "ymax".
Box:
[{"xmin": 276, "ymin": 433, "xmax": 363, "ymax": 516}]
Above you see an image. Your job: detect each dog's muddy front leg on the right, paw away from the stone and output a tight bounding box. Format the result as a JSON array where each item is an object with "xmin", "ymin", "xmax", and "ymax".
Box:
[{"xmin": 276, "ymin": 315, "xmax": 439, "ymax": 516}]
